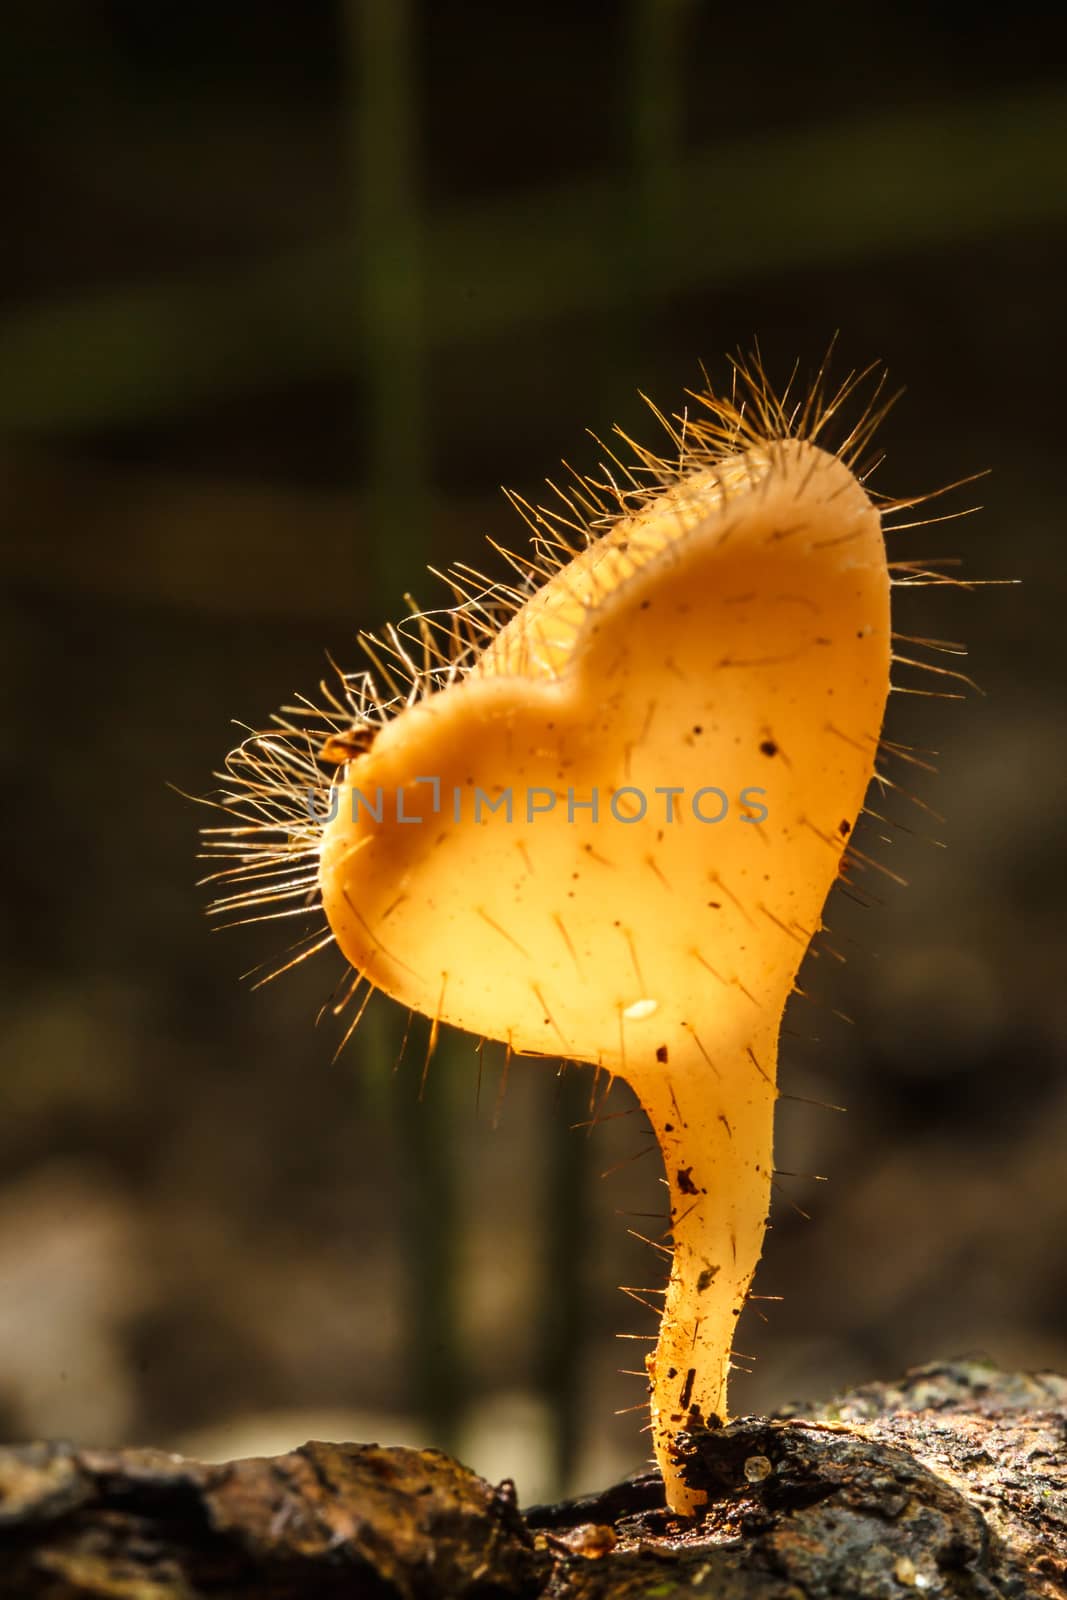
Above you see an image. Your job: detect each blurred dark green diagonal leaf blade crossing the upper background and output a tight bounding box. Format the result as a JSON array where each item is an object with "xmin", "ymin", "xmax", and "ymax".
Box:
[{"xmin": 0, "ymin": 93, "xmax": 1067, "ymax": 430}]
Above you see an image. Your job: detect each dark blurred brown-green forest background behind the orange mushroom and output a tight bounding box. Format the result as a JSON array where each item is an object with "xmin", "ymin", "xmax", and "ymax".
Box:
[{"xmin": 0, "ymin": 0, "xmax": 1067, "ymax": 1499}]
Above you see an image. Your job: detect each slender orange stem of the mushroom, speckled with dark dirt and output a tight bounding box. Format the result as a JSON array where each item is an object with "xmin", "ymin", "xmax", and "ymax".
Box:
[{"xmin": 637, "ymin": 1040, "xmax": 776, "ymax": 1515}]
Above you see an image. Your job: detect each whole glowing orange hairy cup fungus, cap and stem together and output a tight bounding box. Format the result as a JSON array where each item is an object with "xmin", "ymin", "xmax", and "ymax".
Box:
[{"xmin": 202, "ymin": 363, "xmax": 979, "ymax": 1512}]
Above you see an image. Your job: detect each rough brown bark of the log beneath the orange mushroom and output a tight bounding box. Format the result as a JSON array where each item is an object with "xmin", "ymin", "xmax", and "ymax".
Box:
[{"xmin": 0, "ymin": 1363, "xmax": 1067, "ymax": 1600}]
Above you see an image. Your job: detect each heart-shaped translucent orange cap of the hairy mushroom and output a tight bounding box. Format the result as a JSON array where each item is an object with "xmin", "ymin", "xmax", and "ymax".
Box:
[{"xmin": 320, "ymin": 440, "xmax": 891, "ymax": 1080}]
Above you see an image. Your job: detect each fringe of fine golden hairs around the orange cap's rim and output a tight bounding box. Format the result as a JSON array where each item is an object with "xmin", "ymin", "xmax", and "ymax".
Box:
[{"xmin": 202, "ymin": 346, "xmax": 974, "ymax": 1004}]
